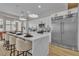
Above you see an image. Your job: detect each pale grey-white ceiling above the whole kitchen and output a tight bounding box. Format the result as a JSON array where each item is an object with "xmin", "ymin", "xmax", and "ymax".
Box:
[{"xmin": 0, "ymin": 3, "xmax": 67, "ymax": 18}]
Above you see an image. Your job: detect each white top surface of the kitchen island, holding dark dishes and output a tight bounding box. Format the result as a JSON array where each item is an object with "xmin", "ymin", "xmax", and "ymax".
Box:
[{"xmin": 8, "ymin": 32, "xmax": 50, "ymax": 41}]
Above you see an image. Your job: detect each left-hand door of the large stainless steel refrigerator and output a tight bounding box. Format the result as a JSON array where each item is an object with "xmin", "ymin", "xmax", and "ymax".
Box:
[{"xmin": 51, "ymin": 22, "xmax": 61, "ymax": 43}]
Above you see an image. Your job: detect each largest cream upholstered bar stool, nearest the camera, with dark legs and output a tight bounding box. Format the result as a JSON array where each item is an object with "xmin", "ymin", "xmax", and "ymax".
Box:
[{"xmin": 16, "ymin": 38, "xmax": 32, "ymax": 56}]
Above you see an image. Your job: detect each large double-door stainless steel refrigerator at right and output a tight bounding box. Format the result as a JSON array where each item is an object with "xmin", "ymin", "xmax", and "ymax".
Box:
[{"xmin": 51, "ymin": 13, "xmax": 78, "ymax": 50}]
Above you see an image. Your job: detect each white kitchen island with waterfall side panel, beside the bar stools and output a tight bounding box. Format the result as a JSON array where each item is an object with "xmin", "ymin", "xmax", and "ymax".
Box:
[{"xmin": 7, "ymin": 32, "xmax": 49, "ymax": 56}]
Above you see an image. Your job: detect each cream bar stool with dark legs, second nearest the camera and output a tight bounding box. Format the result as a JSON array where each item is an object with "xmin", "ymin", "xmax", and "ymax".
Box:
[{"xmin": 9, "ymin": 36, "xmax": 16, "ymax": 56}]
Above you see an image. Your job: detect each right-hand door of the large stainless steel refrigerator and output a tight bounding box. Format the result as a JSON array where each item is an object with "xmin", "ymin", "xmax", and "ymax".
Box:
[{"xmin": 62, "ymin": 17, "xmax": 77, "ymax": 47}]
